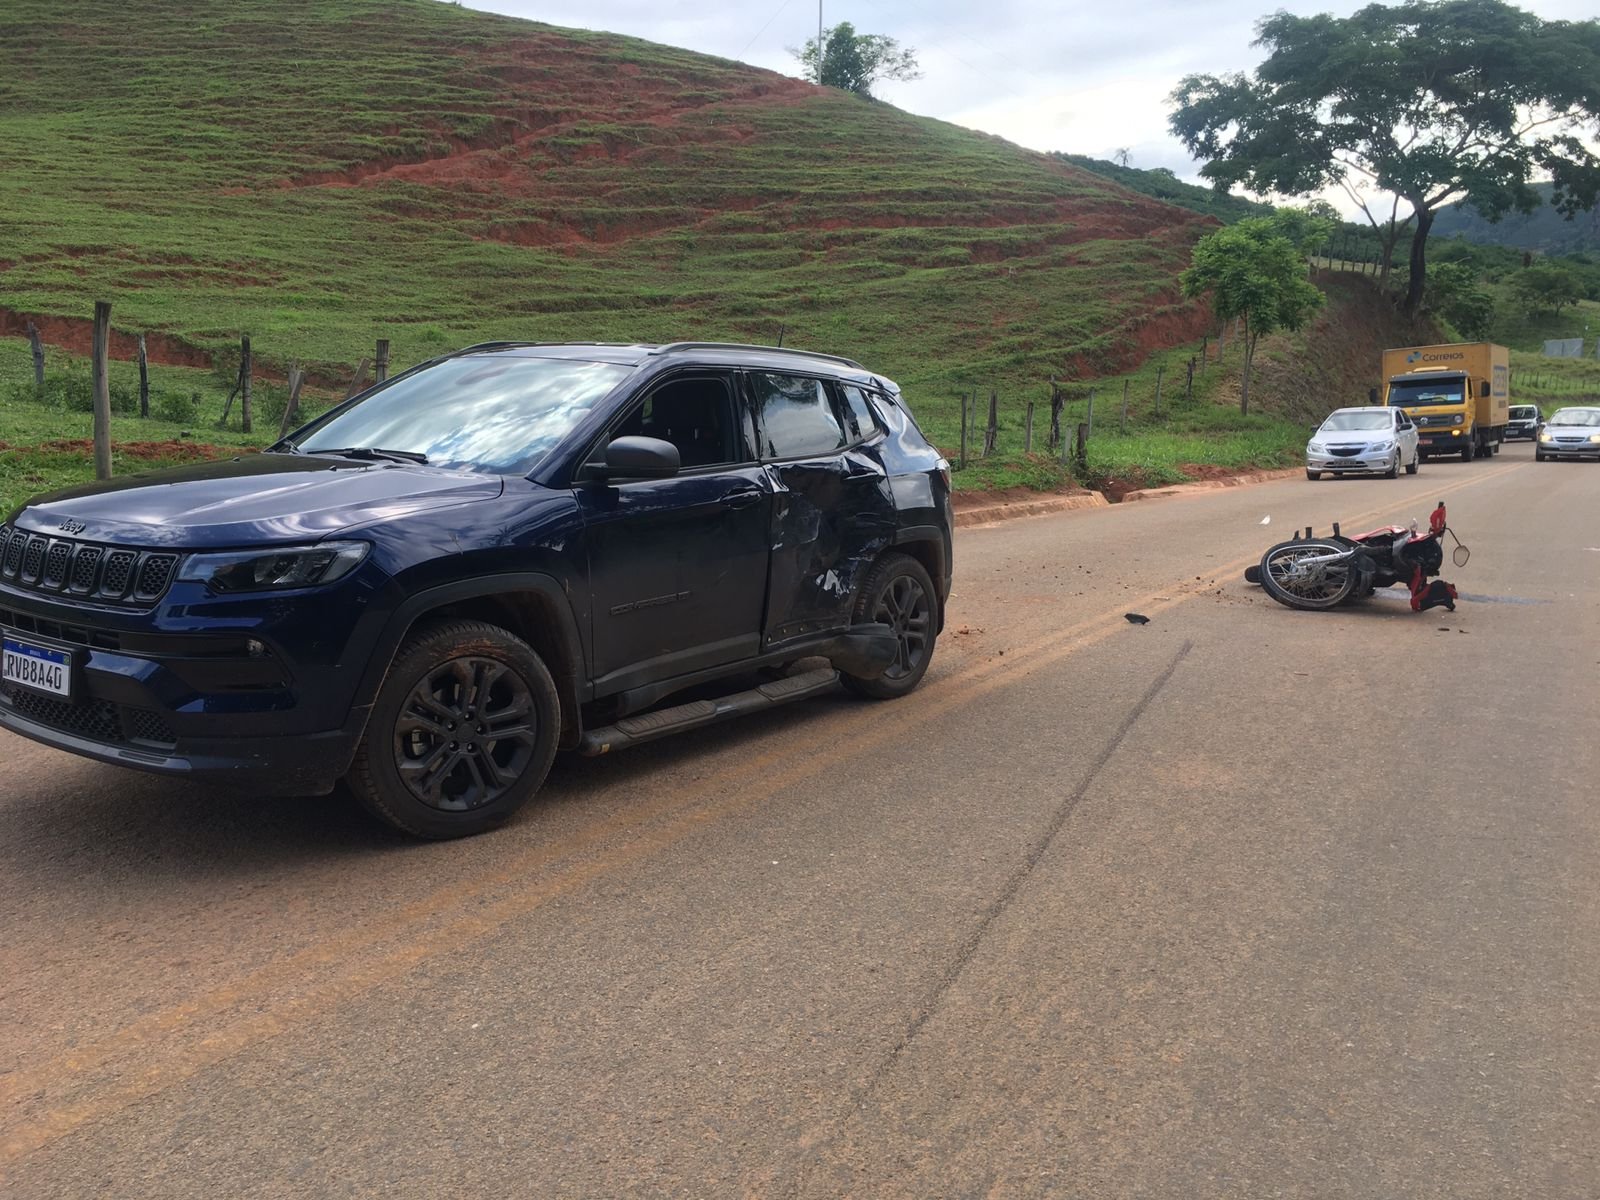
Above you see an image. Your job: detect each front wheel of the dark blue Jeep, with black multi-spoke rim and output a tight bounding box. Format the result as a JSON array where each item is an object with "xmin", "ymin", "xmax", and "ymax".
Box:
[{"xmin": 347, "ymin": 621, "xmax": 562, "ymax": 838}]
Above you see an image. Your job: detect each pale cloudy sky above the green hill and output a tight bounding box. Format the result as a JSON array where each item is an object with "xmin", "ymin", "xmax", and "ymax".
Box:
[{"xmin": 466, "ymin": 0, "xmax": 1595, "ymax": 214}]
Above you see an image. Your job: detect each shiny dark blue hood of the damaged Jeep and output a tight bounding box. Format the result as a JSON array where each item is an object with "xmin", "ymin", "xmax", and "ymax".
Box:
[{"xmin": 7, "ymin": 454, "xmax": 506, "ymax": 549}]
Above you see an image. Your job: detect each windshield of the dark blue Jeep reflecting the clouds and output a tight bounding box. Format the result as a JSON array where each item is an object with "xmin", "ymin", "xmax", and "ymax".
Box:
[{"xmin": 296, "ymin": 354, "xmax": 634, "ymax": 475}]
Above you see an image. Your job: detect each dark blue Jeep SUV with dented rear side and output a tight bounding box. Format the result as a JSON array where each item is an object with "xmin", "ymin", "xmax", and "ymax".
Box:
[{"xmin": 0, "ymin": 342, "xmax": 952, "ymax": 837}]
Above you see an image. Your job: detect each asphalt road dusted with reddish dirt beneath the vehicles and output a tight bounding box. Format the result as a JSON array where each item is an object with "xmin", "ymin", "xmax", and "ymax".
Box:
[{"xmin": 0, "ymin": 446, "xmax": 1600, "ymax": 1200}]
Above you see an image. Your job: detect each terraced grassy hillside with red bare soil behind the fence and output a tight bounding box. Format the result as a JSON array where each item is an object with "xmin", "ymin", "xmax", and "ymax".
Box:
[{"xmin": 0, "ymin": 0, "xmax": 1203, "ymax": 400}]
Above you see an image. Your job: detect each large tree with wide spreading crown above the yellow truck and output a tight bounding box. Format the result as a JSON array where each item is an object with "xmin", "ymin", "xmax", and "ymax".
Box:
[{"xmin": 1170, "ymin": 0, "xmax": 1600, "ymax": 314}]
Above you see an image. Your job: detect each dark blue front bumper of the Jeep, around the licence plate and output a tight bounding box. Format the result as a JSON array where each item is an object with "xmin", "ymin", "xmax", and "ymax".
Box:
[{"xmin": 0, "ymin": 563, "xmax": 396, "ymax": 795}]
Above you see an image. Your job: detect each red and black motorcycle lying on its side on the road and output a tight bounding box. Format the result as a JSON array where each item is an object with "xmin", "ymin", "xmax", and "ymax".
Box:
[{"xmin": 1245, "ymin": 501, "xmax": 1472, "ymax": 613}]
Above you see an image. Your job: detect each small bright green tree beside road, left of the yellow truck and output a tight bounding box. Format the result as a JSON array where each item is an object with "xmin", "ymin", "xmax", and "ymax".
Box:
[{"xmin": 1179, "ymin": 216, "xmax": 1326, "ymax": 413}]
